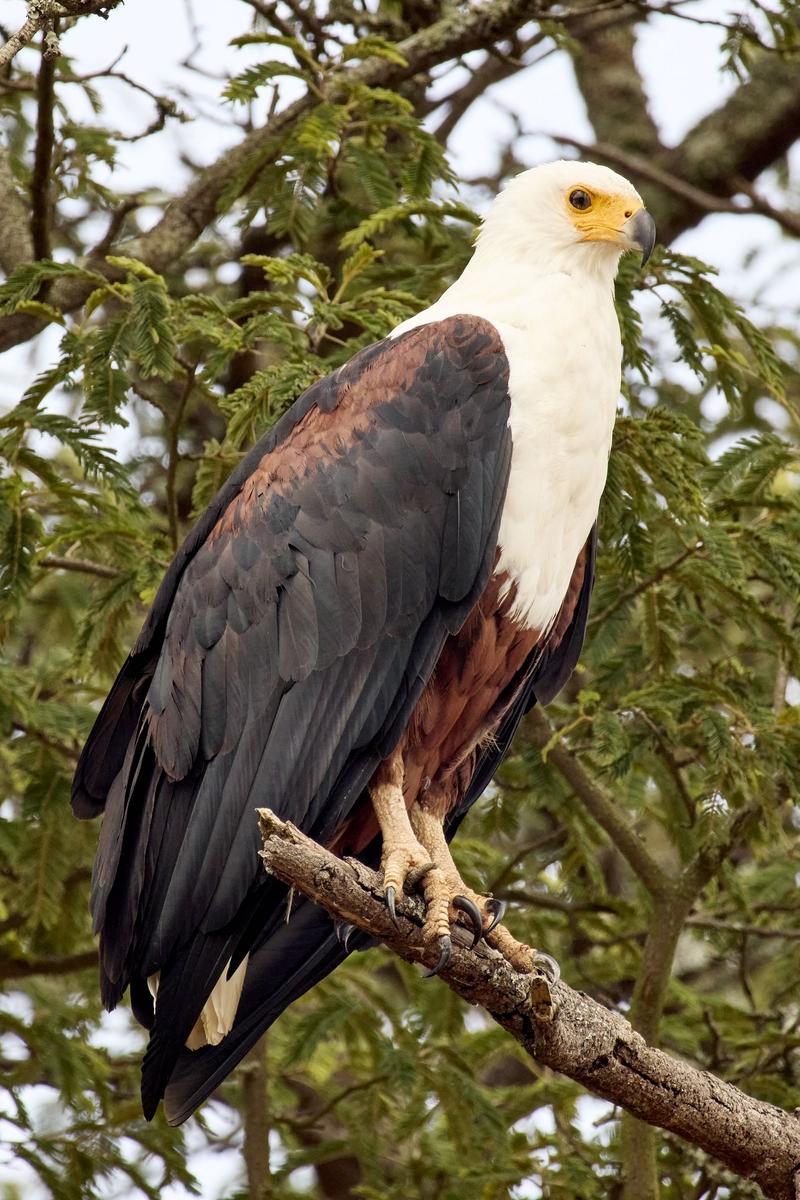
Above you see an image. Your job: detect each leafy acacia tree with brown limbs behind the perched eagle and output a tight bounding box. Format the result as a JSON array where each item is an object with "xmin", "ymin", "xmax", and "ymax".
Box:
[{"xmin": 0, "ymin": 0, "xmax": 800, "ymax": 1200}]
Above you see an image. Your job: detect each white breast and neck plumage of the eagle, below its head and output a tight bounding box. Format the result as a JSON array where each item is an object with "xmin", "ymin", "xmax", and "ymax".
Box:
[{"xmin": 395, "ymin": 268, "xmax": 621, "ymax": 630}]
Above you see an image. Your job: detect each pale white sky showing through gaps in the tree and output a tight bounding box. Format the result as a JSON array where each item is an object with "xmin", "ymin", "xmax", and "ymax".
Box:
[{"xmin": 0, "ymin": 0, "xmax": 800, "ymax": 1200}]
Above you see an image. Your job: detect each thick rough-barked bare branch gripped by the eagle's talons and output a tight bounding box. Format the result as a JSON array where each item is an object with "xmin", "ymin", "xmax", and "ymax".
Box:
[{"xmin": 260, "ymin": 809, "xmax": 800, "ymax": 1200}]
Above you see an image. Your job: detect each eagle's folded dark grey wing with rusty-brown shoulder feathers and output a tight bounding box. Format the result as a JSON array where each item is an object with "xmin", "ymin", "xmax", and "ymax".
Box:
[{"xmin": 74, "ymin": 318, "xmax": 511, "ymax": 1115}]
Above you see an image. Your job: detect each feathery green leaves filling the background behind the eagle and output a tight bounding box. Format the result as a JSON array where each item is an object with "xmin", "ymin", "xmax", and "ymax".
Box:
[{"xmin": 0, "ymin": 5, "xmax": 800, "ymax": 1200}]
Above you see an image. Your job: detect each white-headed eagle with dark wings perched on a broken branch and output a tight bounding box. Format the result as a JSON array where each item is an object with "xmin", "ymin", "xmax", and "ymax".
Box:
[{"xmin": 73, "ymin": 162, "xmax": 655, "ymax": 1124}]
